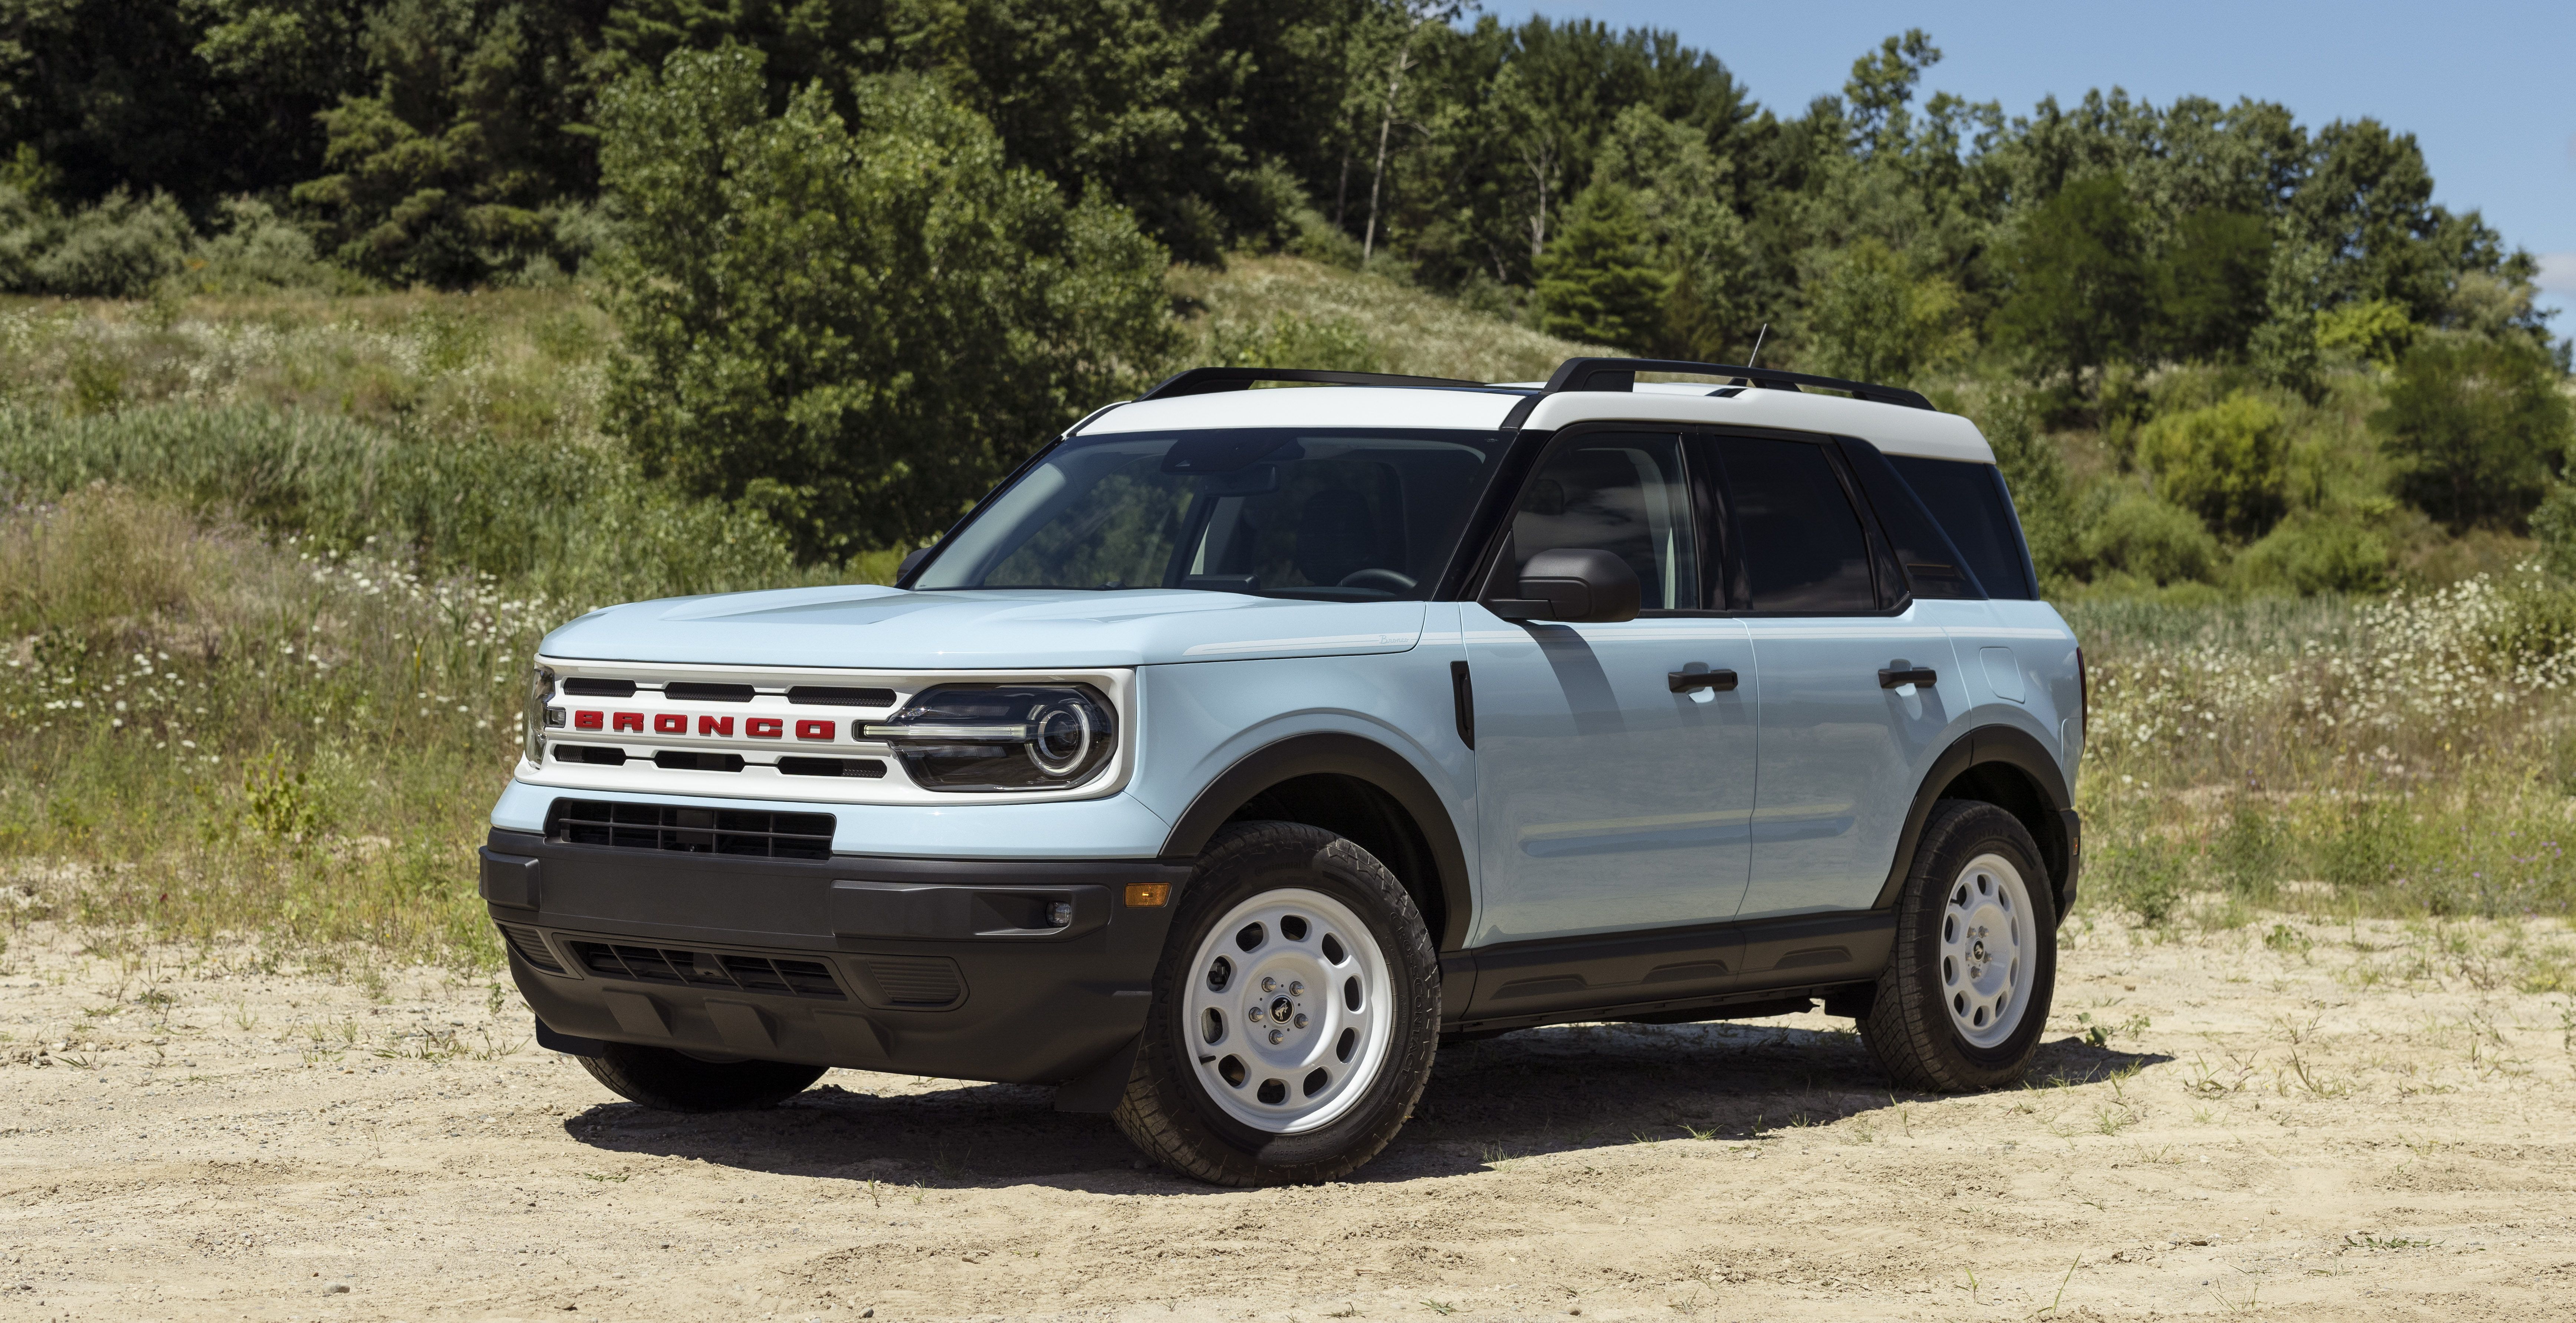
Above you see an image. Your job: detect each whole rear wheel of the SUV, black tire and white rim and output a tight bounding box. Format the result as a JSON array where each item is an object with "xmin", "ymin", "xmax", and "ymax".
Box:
[{"xmin": 1860, "ymin": 801, "xmax": 2058, "ymax": 1091}]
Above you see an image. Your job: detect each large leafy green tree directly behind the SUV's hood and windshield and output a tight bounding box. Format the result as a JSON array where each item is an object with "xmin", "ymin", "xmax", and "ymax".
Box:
[{"xmin": 600, "ymin": 49, "xmax": 1174, "ymax": 558}]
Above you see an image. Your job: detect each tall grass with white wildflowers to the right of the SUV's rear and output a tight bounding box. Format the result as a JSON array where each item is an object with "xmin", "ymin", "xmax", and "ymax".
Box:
[{"xmin": 2069, "ymin": 569, "xmax": 2576, "ymax": 924}]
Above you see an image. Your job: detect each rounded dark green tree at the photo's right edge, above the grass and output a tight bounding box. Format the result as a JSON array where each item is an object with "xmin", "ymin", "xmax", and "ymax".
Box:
[{"xmin": 2370, "ymin": 335, "xmax": 2571, "ymax": 530}]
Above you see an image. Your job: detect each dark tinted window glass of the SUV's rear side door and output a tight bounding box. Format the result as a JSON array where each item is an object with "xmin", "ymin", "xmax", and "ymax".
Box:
[{"xmin": 1718, "ymin": 437, "xmax": 1878, "ymax": 615}]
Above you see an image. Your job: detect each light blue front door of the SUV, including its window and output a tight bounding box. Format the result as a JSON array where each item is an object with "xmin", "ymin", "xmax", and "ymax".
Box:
[{"xmin": 1463, "ymin": 430, "xmax": 1754, "ymax": 945}]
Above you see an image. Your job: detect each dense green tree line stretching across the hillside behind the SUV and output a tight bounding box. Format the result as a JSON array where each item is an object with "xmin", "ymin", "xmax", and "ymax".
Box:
[{"xmin": 0, "ymin": 0, "xmax": 2576, "ymax": 566}]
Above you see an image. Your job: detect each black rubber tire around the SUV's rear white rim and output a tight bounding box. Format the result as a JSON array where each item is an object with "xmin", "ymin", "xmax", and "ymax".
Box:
[{"xmin": 1860, "ymin": 801, "xmax": 2058, "ymax": 1094}]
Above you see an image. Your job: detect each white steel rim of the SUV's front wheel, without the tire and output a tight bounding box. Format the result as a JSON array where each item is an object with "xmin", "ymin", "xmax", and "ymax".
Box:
[{"xmin": 1174, "ymin": 888, "xmax": 1394, "ymax": 1135}]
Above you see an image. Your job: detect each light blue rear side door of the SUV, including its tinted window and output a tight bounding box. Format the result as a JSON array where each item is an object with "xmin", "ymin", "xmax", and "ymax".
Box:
[{"xmin": 1713, "ymin": 435, "xmax": 1960, "ymax": 919}]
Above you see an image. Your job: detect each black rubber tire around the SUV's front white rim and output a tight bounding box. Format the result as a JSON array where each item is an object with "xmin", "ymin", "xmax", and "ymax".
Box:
[{"xmin": 1113, "ymin": 821, "xmax": 1440, "ymax": 1186}]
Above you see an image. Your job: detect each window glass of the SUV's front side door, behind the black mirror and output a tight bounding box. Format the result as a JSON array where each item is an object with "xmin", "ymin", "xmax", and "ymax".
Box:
[{"xmin": 1512, "ymin": 433, "xmax": 1700, "ymax": 610}]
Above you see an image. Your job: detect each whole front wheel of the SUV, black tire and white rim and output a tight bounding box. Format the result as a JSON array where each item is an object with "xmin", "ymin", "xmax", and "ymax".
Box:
[{"xmin": 1116, "ymin": 821, "xmax": 1440, "ymax": 1186}]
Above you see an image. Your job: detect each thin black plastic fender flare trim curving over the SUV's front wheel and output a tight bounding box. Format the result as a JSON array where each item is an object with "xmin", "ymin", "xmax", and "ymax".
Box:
[{"xmin": 1162, "ymin": 733, "xmax": 1476, "ymax": 950}]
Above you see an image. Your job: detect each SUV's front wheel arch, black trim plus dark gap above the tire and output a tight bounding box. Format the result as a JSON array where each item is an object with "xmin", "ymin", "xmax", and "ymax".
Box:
[{"xmin": 1162, "ymin": 733, "xmax": 1473, "ymax": 950}]
